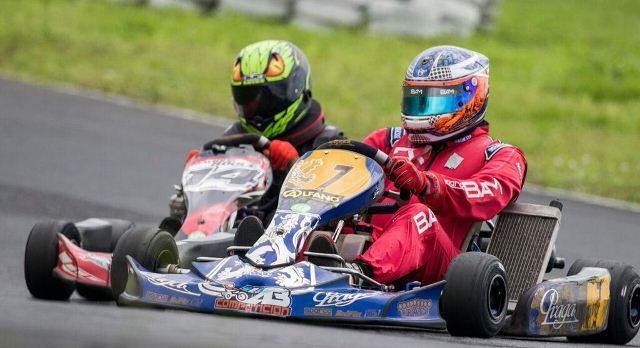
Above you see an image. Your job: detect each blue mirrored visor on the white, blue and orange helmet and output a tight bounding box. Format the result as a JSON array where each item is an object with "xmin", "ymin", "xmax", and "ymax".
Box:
[{"xmin": 402, "ymin": 84, "xmax": 475, "ymax": 116}]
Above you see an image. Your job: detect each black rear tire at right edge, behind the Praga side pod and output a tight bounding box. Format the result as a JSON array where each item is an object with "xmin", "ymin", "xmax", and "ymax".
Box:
[{"xmin": 567, "ymin": 259, "xmax": 640, "ymax": 344}]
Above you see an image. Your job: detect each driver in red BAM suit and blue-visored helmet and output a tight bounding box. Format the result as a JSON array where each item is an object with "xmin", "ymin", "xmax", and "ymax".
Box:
[{"xmin": 314, "ymin": 46, "xmax": 527, "ymax": 284}]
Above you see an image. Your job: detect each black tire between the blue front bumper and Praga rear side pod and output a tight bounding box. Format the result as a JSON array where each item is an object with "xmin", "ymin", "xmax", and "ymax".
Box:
[{"xmin": 440, "ymin": 252, "xmax": 508, "ymax": 338}]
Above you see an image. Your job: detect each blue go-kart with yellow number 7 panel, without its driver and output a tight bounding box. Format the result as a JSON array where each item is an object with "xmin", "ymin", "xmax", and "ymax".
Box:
[{"xmin": 114, "ymin": 141, "xmax": 640, "ymax": 344}]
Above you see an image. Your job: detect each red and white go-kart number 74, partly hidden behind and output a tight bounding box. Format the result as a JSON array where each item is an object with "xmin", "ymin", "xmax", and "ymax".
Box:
[{"xmin": 25, "ymin": 135, "xmax": 273, "ymax": 300}]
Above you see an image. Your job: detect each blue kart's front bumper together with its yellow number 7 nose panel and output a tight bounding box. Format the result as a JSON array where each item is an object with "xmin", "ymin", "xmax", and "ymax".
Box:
[{"xmin": 120, "ymin": 149, "xmax": 444, "ymax": 328}]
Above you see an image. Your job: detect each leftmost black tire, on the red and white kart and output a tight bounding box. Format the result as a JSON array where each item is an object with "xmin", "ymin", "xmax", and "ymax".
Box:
[{"xmin": 24, "ymin": 221, "xmax": 80, "ymax": 301}]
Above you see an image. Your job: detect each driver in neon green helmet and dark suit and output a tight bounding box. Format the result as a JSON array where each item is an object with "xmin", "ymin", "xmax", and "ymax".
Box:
[{"xmin": 169, "ymin": 40, "xmax": 343, "ymax": 228}]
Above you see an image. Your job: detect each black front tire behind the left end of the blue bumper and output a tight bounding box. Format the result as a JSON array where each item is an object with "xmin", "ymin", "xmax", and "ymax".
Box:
[{"xmin": 111, "ymin": 227, "xmax": 179, "ymax": 302}]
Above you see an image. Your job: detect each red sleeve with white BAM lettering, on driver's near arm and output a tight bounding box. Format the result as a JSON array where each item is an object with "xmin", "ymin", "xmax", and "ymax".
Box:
[{"xmin": 422, "ymin": 146, "xmax": 527, "ymax": 221}]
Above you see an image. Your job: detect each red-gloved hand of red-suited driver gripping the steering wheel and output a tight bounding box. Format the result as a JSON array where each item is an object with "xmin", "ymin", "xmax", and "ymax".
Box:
[{"xmin": 386, "ymin": 157, "xmax": 431, "ymax": 195}]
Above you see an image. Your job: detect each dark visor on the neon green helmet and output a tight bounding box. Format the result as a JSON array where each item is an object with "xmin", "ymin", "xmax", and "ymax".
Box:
[{"xmin": 231, "ymin": 83, "xmax": 291, "ymax": 123}]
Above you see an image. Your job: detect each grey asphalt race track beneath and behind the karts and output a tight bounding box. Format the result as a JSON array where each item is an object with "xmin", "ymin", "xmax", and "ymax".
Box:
[{"xmin": 0, "ymin": 78, "xmax": 640, "ymax": 347}]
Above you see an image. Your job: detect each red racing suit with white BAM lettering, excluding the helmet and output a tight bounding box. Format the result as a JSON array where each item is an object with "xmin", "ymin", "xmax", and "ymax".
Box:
[{"xmin": 359, "ymin": 124, "xmax": 527, "ymax": 285}]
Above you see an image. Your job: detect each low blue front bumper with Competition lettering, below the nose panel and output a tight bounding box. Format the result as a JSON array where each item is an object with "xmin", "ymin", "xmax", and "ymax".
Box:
[{"xmin": 120, "ymin": 256, "xmax": 445, "ymax": 329}]
